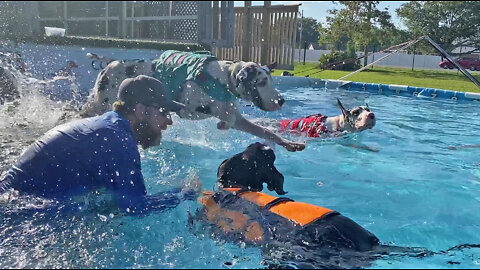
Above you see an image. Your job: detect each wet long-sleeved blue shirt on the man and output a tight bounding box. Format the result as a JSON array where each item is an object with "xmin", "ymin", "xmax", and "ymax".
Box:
[{"xmin": 0, "ymin": 111, "xmax": 186, "ymax": 214}]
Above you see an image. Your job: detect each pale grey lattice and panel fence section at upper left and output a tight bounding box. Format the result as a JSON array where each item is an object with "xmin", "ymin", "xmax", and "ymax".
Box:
[{"xmin": 13, "ymin": 1, "xmax": 235, "ymax": 47}]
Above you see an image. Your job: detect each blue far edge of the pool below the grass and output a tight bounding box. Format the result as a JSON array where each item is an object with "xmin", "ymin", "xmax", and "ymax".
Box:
[{"xmin": 273, "ymin": 76, "xmax": 480, "ymax": 102}]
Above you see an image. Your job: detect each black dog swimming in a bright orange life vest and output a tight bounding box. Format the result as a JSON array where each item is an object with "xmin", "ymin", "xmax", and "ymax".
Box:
[{"xmin": 196, "ymin": 143, "xmax": 418, "ymax": 268}]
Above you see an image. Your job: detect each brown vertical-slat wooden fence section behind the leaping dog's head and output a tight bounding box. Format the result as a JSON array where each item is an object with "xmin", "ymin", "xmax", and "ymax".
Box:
[{"xmin": 214, "ymin": 5, "xmax": 298, "ymax": 69}]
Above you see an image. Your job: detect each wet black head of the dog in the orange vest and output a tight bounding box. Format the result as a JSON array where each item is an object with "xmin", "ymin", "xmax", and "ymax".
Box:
[{"xmin": 217, "ymin": 142, "xmax": 286, "ymax": 195}]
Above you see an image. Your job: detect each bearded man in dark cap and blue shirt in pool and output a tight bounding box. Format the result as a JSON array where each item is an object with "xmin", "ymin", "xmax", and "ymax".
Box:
[{"xmin": 0, "ymin": 75, "xmax": 200, "ymax": 214}]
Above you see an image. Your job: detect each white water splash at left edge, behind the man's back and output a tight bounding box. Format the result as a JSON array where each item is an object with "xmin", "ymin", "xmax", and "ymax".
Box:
[{"xmin": 0, "ymin": 53, "xmax": 82, "ymax": 173}]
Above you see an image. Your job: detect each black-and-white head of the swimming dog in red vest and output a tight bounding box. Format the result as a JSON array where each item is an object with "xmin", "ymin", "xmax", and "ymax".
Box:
[{"xmin": 337, "ymin": 99, "xmax": 376, "ymax": 132}]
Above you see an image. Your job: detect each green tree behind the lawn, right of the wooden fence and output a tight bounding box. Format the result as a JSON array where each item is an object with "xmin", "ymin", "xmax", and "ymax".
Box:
[{"xmin": 320, "ymin": 1, "xmax": 395, "ymax": 65}]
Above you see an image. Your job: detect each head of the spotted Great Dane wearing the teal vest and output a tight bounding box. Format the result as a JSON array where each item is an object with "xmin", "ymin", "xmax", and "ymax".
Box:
[{"xmin": 231, "ymin": 62, "xmax": 285, "ymax": 111}]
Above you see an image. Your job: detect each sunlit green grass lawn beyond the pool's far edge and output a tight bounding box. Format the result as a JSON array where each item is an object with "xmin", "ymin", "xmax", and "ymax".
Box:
[{"xmin": 273, "ymin": 63, "xmax": 480, "ymax": 93}]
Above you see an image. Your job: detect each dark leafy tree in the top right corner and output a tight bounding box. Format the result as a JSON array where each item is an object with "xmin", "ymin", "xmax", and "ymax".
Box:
[{"xmin": 396, "ymin": 1, "xmax": 480, "ymax": 51}]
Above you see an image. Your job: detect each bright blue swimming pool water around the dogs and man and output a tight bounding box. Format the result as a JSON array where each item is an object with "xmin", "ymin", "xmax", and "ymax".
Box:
[{"xmin": 0, "ymin": 83, "xmax": 480, "ymax": 269}]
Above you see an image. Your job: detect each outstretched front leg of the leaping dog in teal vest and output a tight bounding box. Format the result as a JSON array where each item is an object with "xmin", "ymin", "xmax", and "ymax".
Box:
[{"xmin": 233, "ymin": 114, "xmax": 305, "ymax": 152}]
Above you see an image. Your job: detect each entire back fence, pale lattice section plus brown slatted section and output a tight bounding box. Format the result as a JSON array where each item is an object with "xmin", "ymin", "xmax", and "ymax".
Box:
[{"xmin": 0, "ymin": 1, "xmax": 299, "ymax": 69}]
